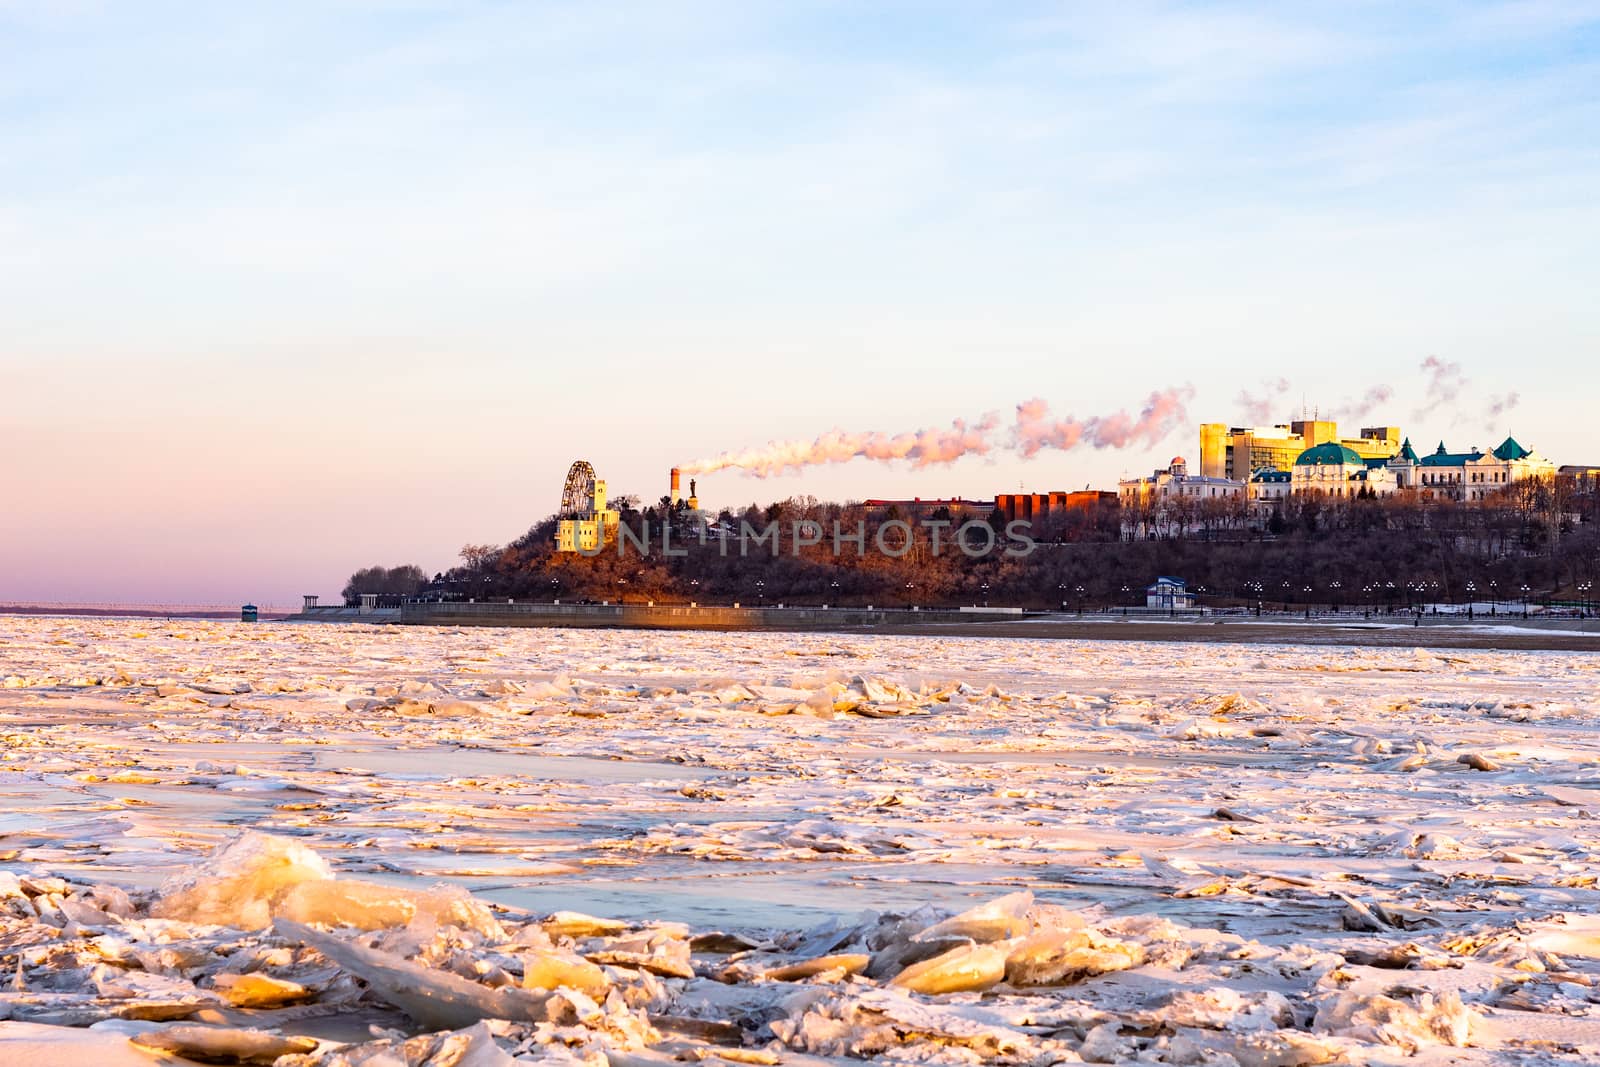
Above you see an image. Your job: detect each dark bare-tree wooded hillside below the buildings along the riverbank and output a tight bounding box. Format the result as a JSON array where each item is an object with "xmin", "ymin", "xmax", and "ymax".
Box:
[{"xmin": 346, "ymin": 478, "xmax": 1600, "ymax": 609}]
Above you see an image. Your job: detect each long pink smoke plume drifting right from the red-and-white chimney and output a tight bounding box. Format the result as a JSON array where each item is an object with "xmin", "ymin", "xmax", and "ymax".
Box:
[{"xmin": 682, "ymin": 386, "xmax": 1194, "ymax": 478}]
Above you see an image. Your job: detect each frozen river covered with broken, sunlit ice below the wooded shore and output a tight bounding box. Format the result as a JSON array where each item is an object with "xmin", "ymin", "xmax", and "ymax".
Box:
[{"xmin": 0, "ymin": 617, "xmax": 1600, "ymax": 1064}]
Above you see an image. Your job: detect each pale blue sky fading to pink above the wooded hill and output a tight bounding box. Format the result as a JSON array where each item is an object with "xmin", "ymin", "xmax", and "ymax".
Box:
[{"xmin": 0, "ymin": 0, "xmax": 1600, "ymax": 603}]
